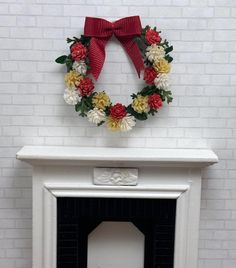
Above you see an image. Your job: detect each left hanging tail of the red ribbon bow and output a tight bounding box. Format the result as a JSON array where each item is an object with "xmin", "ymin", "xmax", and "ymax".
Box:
[{"xmin": 88, "ymin": 37, "xmax": 108, "ymax": 80}]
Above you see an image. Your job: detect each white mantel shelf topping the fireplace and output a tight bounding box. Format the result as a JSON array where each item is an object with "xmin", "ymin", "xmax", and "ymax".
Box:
[{"xmin": 16, "ymin": 146, "xmax": 218, "ymax": 167}]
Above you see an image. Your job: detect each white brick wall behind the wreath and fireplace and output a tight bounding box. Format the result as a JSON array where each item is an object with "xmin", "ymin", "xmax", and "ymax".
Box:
[{"xmin": 0, "ymin": 0, "xmax": 236, "ymax": 268}]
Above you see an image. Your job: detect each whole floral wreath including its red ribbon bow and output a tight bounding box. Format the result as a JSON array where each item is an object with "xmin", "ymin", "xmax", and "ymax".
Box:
[{"xmin": 56, "ymin": 16, "xmax": 173, "ymax": 131}]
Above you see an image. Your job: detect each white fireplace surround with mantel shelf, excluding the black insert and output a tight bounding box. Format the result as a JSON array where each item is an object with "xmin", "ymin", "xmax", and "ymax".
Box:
[{"xmin": 17, "ymin": 146, "xmax": 218, "ymax": 268}]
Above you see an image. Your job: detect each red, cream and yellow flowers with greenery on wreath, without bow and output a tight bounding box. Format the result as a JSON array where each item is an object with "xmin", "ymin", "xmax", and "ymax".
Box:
[{"xmin": 56, "ymin": 26, "xmax": 173, "ymax": 132}]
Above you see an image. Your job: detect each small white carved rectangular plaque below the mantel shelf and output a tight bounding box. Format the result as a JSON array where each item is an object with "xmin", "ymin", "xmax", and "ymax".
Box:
[{"xmin": 94, "ymin": 168, "xmax": 138, "ymax": 185}]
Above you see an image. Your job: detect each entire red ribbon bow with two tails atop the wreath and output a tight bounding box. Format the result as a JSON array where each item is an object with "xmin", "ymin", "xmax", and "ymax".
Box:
[{"xmin": 84, "ymin": 16, "xmax": 144, "ymax": 80}]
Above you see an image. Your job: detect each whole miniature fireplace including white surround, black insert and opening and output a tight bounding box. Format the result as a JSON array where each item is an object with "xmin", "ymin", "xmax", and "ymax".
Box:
[{"xmin": 17, "ymin": 146, "xmax": 218, "ymax": 268}]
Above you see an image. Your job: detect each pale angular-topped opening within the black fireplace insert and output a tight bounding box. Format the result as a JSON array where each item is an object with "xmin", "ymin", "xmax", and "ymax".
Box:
[{"xmin": 88, "ymin": 222, "xmax": 144, "ymax": 268}]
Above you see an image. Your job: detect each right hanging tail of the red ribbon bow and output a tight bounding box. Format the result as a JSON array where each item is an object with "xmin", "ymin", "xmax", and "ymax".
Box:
[{"xmin": 118, "ymin": 37, "xmax": 144, "ymax": 78}]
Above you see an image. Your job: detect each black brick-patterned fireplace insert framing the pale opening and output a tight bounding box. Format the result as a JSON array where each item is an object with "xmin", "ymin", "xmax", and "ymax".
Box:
[{"xmin": 57, "ymin": 197, "xmax": 176, "ymax": 268}]
